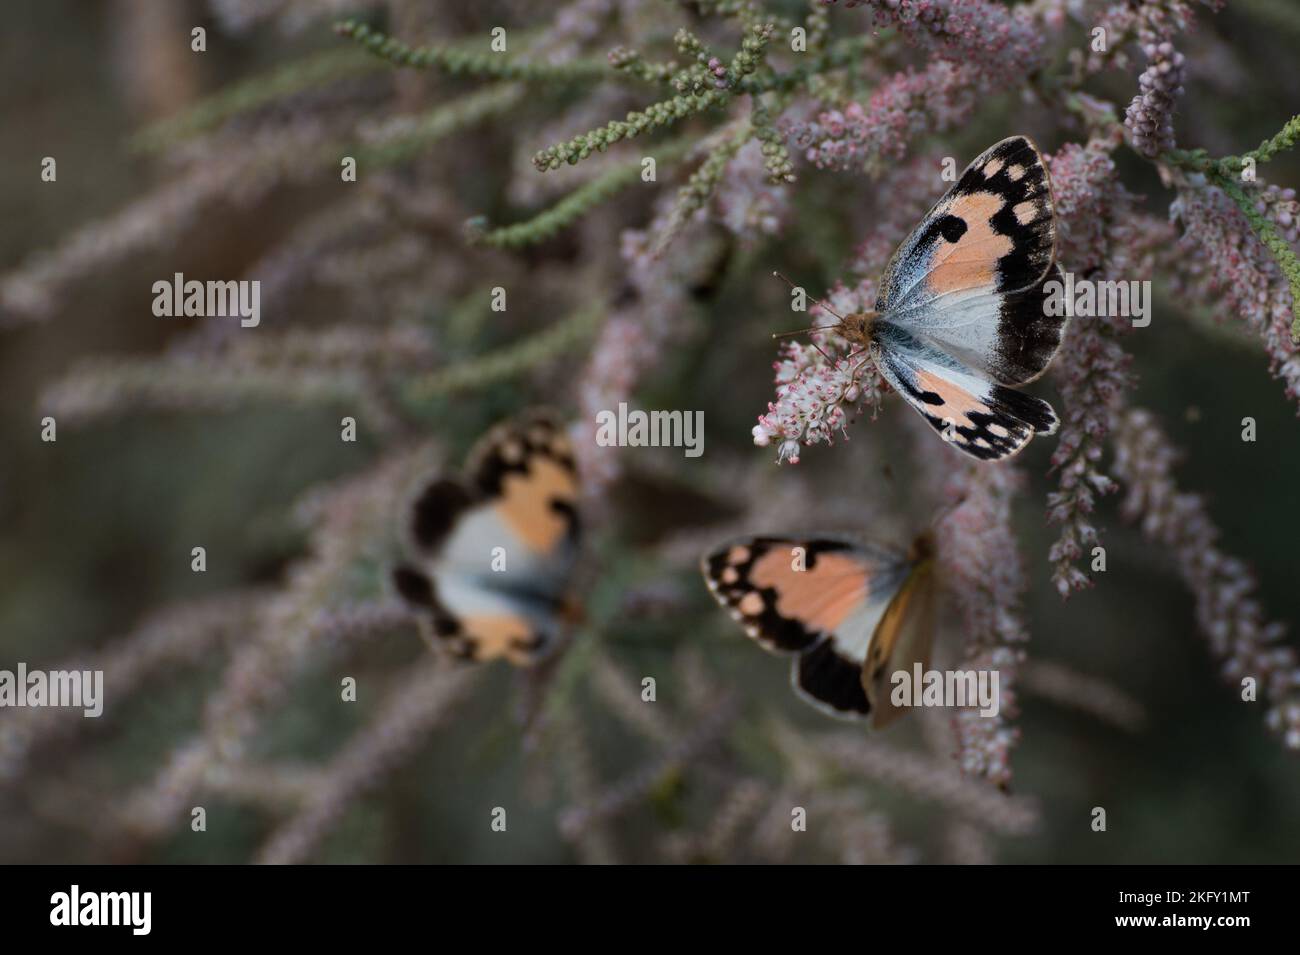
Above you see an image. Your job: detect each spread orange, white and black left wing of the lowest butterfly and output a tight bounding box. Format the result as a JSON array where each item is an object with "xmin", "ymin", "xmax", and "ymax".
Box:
[{"xmin": 701, "ymin": 537, "xmax": 906, "ymax": 716}]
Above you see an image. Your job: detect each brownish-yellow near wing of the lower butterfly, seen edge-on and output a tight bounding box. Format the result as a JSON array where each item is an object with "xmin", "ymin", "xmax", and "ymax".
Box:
[{"xmin": 862, "ymin": 559, "xmax": 935, "ymax": 729}]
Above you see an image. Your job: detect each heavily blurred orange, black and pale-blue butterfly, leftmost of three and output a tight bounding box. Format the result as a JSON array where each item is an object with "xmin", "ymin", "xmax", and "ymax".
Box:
[{"xmin": 393, "ymin": 411, "xmax": 580, "ymax": 665}]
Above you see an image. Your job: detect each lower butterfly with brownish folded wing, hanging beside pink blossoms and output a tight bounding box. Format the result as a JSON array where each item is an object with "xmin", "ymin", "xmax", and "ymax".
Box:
[{"xmin": 701, "ymin": 533, "xmax": 935, "ymax": 728}]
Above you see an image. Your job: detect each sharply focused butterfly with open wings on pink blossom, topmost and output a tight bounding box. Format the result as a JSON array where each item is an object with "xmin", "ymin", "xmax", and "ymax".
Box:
[{"xmin": 774, "ymin": 136, "xmax": 1066, "ymax": 460}]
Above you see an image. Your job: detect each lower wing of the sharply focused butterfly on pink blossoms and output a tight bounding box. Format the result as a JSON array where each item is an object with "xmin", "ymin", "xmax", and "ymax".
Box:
[{"xmin": 875, "ymin": 321, "xmax": 1060, "ymax": 461}]
